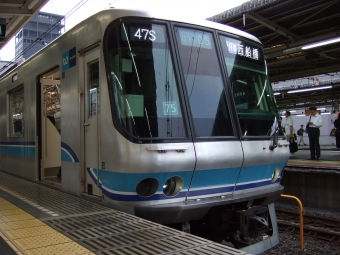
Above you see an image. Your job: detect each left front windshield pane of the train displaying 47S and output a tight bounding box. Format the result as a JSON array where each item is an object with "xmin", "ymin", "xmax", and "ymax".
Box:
[{"xmin": 106, "ymin": 22, "xmax": 187, "ymax": 140}]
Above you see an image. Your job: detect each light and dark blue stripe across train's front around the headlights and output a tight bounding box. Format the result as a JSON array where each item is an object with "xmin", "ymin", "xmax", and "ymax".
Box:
[{"xmin": 87, "ymin": 162, "xmax": 284, "ymax": 201}]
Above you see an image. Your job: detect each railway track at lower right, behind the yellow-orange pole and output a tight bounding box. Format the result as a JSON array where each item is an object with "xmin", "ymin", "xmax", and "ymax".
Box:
[{"xmin": 276, "ymin": 208, "xmax": 340, "ymax": 246}]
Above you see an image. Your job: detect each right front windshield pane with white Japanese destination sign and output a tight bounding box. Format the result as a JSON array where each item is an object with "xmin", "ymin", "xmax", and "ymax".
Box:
[{"xmin": 220, "ymin": 35, "xmax": 277, "ymax": 136}]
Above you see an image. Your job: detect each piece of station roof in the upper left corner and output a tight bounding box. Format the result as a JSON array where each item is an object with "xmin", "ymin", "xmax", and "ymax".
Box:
[{"xmin": 0, "ymin": 0, "xmax": 49, "ymax": 50}]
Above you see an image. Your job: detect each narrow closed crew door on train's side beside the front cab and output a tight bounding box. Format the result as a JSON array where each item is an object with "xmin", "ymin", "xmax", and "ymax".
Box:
[{"xmin": 84, "ymin": 48, "xmax": 102, "ymax": 196}]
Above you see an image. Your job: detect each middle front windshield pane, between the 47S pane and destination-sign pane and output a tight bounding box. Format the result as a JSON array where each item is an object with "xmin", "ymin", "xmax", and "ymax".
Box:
[{"xmin": 175, "ymin": 27, "xmax": 234, "ymax": 137}]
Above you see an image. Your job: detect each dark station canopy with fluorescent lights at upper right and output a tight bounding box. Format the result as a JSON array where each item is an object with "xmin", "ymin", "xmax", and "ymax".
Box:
[{"xmin": 209, "ymin": 0, "xmax": 340, "ymax": 109}]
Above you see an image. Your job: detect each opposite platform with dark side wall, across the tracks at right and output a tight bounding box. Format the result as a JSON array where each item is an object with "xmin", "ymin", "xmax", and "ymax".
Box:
[{"xmin": 278, "ymin": 145, "xmax": 340, "ymax": 213}]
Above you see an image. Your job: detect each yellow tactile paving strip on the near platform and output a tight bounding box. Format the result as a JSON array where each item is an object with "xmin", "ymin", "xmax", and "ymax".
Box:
[{"xmin": 0, "ymin": 197, "xmax": 94, "ymax": 255}]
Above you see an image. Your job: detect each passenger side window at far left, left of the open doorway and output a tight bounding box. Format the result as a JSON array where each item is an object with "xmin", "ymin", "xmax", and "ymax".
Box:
[{"xmin": 8, "ymin": 85, "xmax": 24, "ymax": 137}]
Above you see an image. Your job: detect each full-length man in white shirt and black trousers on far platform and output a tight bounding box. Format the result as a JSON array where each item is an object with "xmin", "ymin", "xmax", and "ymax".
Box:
[{"xmin": 307, "ymin": 106, "xmax": 322, "ymax": 160}]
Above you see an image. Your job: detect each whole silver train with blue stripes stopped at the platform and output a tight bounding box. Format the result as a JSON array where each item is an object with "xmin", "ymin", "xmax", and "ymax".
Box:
[{"xmin": 0, "ymin": 9, "xmax": 289, "ymax": 252}]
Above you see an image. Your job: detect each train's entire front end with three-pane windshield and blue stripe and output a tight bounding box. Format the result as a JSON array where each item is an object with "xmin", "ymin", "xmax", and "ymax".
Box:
[{"xmin": 100, "ymin": 18, "xmax": 289, "ymax": 251}]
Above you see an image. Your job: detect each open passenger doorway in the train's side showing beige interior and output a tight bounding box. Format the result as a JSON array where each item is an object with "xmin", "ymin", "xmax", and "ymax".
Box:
[{"xmin": 40, "ymin": 68, "xmax": 61, "ymax": 186}]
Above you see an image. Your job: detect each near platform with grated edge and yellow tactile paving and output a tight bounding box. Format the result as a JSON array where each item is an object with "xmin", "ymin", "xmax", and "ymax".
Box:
[{"xmin": 0, "ymin": 171, "xmax": 249, "ymax": 255}]
